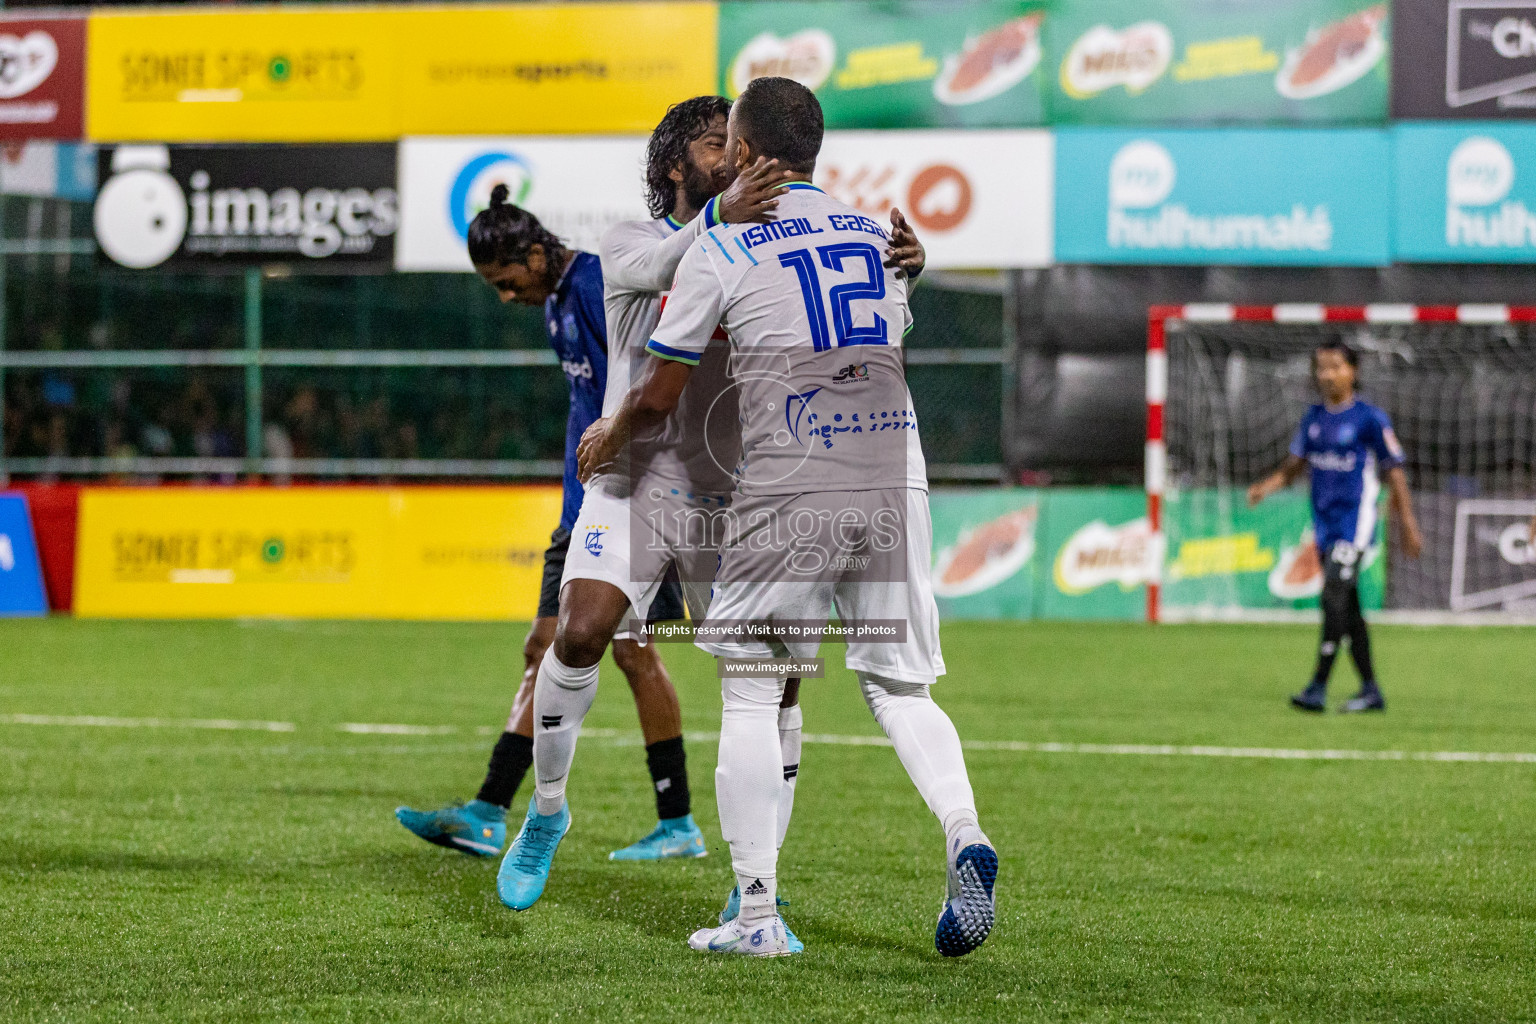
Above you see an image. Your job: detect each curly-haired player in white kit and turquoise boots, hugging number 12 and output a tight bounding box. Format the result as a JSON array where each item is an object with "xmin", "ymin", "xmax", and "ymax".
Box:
[{"xmin": 496, "ymin": 97, "xmax": 799, "ymax": 910}]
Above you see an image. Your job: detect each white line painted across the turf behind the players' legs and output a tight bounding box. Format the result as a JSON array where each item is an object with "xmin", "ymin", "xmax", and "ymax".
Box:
[{"xmin": 0, "ymin": 714, "xmax": 1536, "ymax": 765}]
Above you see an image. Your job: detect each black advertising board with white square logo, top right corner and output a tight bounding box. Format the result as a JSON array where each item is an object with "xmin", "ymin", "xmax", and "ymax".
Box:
[{"xmin": 1392, "ymin": 0, "xmax": 1536, "ymax": 120}]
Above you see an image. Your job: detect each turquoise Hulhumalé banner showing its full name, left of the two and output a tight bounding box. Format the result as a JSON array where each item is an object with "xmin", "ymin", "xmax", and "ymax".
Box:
[{"xmin": 1055, "ymin": 127, "xmax": 1392, "ymax": 266}]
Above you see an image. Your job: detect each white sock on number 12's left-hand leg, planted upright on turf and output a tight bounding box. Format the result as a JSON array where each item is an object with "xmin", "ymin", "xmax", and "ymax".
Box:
[{"xmin": 714, "ymin": 677, "xmax": 783, "ymax": 923}]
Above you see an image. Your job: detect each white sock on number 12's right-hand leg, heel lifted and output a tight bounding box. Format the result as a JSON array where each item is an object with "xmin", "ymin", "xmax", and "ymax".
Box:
[{"xmin": 859, "ymin": 672, "xmax": 977, "ymax": 838}]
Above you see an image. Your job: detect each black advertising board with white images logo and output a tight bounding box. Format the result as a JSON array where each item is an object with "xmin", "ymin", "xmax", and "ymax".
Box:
[{"xmin": 94, "ymin": 143, "xmax": 399, "ymax": 273}]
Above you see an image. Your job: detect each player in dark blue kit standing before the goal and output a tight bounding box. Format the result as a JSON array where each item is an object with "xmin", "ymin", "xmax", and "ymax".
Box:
[{"xmin": 1249, "ymin": 341, "xmax": 1424, "ymax": 712}]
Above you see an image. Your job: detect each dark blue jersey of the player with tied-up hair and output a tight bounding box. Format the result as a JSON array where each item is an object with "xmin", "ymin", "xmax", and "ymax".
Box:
[{"xmin": 544, "ymin": 252, "xmax": 608, "ymax": 530}]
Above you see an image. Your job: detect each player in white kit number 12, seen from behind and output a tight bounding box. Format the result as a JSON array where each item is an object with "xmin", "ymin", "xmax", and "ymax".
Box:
[{"xmin": 578, "ymin": 78, "xmax": 997, "ymax": 956}]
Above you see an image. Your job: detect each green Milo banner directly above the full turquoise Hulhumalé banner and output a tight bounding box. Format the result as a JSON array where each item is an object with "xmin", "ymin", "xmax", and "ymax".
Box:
[{"xmin": 1044, "ymin": 0, "xmax": 1390, "ymax": 124}]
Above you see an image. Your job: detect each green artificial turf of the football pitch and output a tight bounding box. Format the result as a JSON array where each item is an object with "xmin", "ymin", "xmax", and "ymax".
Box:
[{"xmin": 0, "ymin": 620, "xmax": 1536, "ymax": 1024}]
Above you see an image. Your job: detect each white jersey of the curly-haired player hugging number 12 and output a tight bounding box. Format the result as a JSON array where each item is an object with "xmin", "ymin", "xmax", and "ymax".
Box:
[{"xmin": 593, "ymin": 213, "xmax": 742, "ymax": 494}]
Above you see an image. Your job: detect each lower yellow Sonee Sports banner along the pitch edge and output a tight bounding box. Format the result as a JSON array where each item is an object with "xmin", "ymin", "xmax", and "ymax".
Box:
[{"xmin": 75, "ymin": 487, "xmax": 561, "ymax": 620}]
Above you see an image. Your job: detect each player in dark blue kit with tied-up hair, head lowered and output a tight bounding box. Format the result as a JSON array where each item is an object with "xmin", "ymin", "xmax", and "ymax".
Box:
[{"xmin": 395, "ymin": 184, "xmax": 705, "ymax": 860}]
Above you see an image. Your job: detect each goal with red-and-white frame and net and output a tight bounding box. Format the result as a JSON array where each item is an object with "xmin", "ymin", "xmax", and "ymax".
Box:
[{"xmin": 1147, "ymin": 306, "xmax": 1536, "ymax": 620}]
